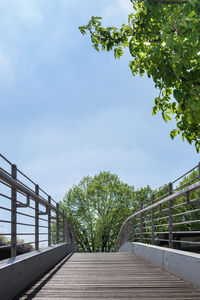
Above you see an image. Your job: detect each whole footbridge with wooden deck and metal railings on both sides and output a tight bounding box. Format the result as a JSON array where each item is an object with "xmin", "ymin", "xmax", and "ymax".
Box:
[{"xmin": 0, "ymin": 154, "xmax": 200, "ymax": 300}]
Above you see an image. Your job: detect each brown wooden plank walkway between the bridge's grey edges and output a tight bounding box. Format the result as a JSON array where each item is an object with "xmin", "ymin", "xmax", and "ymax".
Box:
[{"xmin": 17, "ymin": 253, "xmax": 200, "ymax": 300}]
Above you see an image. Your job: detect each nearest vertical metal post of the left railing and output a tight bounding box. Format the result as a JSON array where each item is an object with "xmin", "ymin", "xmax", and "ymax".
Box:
[{"xmin": 11, "ymin": 165, "xmax": 17, "ymax": 257}]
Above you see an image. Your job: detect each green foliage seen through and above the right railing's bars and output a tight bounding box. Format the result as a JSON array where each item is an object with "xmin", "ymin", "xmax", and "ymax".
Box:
[{"xmin": 120, "ymin": 168, "xmax": 200, "ymax": 247}]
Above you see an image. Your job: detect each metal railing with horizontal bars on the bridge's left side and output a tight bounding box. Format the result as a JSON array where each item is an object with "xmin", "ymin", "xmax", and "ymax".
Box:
[{"xmin": 0, "ymin": 154, "xmax": 75, "ymax": 257}]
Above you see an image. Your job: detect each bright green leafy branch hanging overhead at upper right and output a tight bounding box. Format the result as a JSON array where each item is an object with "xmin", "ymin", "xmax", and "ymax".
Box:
[{"xmin": 79, "ymin": 0, "xmax": 200, "ymax": 152}]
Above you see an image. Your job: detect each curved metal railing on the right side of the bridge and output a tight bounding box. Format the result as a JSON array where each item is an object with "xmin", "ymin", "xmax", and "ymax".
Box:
[{"xmin": 115, "ymin": 163, "xmax": 200, "ymax": 253}]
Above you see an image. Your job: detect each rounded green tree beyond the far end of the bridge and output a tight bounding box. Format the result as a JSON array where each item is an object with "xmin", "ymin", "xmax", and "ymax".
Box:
[{"xmin": 63, "ymin": 172, "xmax": 134, "ymax": 252}]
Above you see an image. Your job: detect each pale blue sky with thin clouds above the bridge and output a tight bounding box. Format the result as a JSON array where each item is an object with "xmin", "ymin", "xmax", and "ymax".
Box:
[{"xmin": 0, "ymin": 0, "xmax": 200, "ymax": 201}]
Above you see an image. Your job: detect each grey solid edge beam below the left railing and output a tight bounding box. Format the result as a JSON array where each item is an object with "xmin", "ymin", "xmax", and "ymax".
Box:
[{"xmin": 0, "ymin": 244, "xmax": 76, "ymax": 300}]
